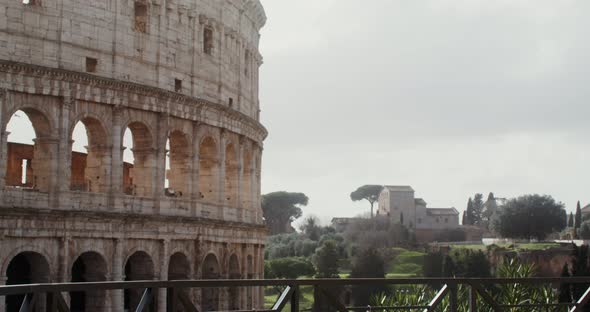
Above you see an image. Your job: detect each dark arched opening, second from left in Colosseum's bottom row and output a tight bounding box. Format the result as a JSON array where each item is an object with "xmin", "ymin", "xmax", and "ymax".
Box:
[{"xmin": 70, "ymin": 252, "xmax": 107, "ymax": 312}]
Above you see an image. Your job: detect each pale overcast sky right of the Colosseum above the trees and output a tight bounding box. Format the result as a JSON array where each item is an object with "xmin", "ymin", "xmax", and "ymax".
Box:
[{"xmin": 260, "ymin": 0, "xmax": 590, "ymax": 222}]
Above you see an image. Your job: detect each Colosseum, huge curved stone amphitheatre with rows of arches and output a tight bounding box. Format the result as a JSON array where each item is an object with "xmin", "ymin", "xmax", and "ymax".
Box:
[{"xmin": 0, "ymin": 0, "xmax": 267, "ymax": 312}]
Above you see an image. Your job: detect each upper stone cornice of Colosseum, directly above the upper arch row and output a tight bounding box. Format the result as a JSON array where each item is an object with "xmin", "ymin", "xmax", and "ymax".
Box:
[{"xmin": 0, "ymin": 60, "xmax": 268, "ymax": 142}]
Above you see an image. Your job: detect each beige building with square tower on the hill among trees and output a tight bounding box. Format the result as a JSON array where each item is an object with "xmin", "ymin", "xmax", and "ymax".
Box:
[{"xmin": 377, "ymin": 185, "xmax": 459, "ymax": 230}]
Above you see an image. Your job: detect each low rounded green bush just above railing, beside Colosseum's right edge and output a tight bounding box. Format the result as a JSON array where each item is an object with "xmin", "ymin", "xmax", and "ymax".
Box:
[{"xmin": 264, "ymin": 257, "xmax": 315, "ymax": 279}]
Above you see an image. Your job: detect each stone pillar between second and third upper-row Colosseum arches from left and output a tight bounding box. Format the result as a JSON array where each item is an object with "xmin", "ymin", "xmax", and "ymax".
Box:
[{"xmin": 107, "ymin": 107, "xmax": 123, "ymax": 210}]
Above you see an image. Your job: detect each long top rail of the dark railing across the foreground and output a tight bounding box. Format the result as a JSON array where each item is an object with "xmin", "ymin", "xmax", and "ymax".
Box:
[{"xmin": 0, "ymin": 277, "xmax": 590, "ymax": 296}]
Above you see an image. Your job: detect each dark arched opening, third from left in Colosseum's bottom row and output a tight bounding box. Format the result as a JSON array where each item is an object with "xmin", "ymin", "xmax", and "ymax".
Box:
[{"xmin": 123, "ymin": 251, "xmax": 156, "ymax": 311}]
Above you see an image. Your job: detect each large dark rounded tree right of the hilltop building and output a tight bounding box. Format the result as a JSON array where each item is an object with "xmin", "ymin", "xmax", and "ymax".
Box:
[{"xmin": 495, "ymin": 195, "xmax": 566, "ymax": 240}]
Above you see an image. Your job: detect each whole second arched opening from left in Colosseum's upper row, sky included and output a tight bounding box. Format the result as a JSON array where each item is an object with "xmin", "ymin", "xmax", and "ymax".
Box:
[{"xmin": 71, "ymin": 117, "xmax": 111, "ymax": 193}]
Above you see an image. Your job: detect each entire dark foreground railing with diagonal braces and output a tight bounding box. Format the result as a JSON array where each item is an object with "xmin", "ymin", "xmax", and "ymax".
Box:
[{"xmin": 0, "ymin": 277, "xmax": 590, "ymax": 312}]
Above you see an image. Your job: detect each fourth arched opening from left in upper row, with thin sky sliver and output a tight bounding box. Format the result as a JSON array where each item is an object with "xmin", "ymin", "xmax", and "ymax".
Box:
[{"xmin": 166, "ymin": 131, "xmax": 191, "ymax": 197}]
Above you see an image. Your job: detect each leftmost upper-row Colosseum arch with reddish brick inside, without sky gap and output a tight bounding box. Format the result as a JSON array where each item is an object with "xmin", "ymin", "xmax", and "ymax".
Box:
[{"xmin": 3, "ymin": 106, "xmax": 57, "ymax": 192}]
